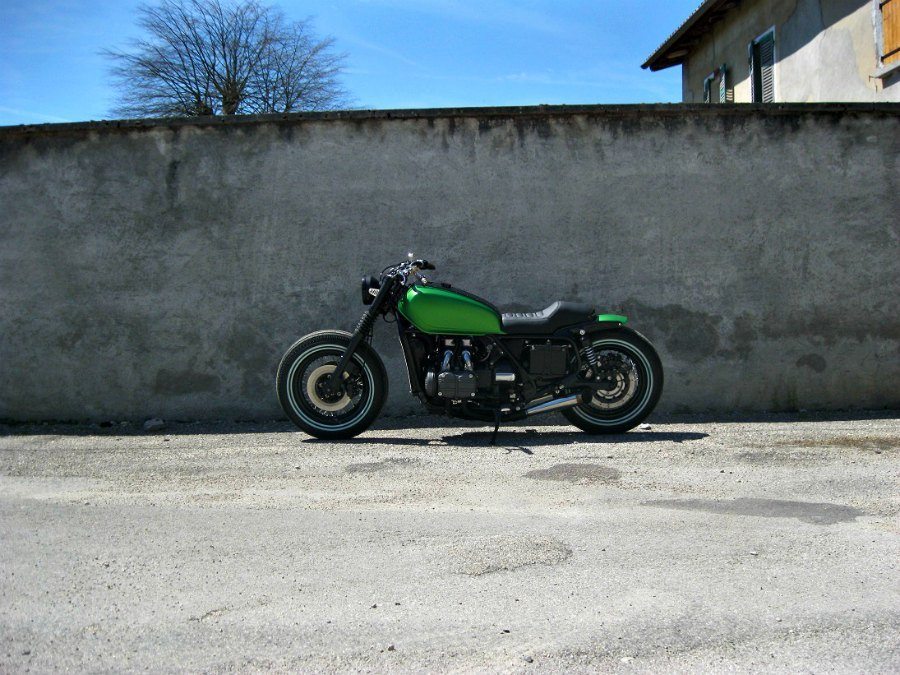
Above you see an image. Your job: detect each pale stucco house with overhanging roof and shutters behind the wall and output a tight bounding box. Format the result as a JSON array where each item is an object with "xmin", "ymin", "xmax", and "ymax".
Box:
[{"xmin": 643, "ymin": 0, "xmax": 900, "ymax": 103}]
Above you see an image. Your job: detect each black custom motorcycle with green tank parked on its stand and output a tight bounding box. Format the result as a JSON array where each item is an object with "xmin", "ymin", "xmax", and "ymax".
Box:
[{"xmin": 275, "ymin": 256, "xmax": 663, "ymax": 443}]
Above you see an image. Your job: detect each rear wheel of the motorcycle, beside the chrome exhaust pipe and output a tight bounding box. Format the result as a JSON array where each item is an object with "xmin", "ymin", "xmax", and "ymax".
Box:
[{"xmin": 562, "ymin": 328, "xmax": 663, "ymax": 434}]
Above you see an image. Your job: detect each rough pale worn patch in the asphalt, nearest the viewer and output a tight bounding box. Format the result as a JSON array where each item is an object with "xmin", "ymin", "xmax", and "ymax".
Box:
[{"xmin": 448, "ymin": 535, "xmax": 572, "ymax": 577}]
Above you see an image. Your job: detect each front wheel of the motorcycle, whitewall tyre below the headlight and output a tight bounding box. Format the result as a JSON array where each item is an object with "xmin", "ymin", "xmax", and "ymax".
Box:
[{"xmin": 275, "ymin": 331, "xmax": 388, "ymax": 439}]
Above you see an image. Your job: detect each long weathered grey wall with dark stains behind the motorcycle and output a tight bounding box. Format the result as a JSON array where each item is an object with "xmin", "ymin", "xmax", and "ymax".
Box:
[{"xmin": 0, "ymin": 105, "xmax": 900, "ymax": 419}]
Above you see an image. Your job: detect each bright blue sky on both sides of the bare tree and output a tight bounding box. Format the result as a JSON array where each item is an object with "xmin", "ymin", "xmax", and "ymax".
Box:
[{"xmin": 0, "ymin": 0, "xmax": 698, "ymax": 125}]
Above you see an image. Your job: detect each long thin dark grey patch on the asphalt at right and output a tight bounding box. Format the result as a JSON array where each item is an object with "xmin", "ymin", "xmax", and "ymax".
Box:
[{"xmin": 644, "ymin": 497, "xmax": 865, "ymax": 525}]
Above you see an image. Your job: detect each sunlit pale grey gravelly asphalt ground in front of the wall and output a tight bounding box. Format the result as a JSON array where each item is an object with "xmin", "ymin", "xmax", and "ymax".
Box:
[{"xmin": 0, "ymin": 414, "xmax": 900, "ymax": 673}]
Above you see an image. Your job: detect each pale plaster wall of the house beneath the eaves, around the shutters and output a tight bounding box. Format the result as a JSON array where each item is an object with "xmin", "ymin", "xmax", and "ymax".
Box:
[{"xmin": 682, "ymin": 0, "xmax": 900, "ymax": 103}]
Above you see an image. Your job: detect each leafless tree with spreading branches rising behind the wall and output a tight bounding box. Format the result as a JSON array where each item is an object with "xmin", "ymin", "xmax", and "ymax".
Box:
[{"xmin": 104, "ymin": 0, "xmax": 347, "ymax": 117}]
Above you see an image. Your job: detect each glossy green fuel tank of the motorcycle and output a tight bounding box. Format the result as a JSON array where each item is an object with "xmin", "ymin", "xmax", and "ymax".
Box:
[{"xmin": 397, "ymin": 284, "xmax": 503, "ymax": 335}]
